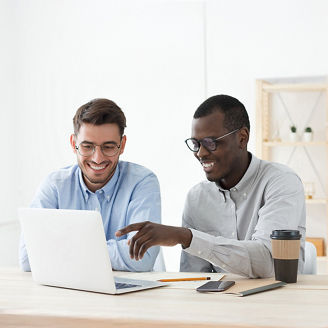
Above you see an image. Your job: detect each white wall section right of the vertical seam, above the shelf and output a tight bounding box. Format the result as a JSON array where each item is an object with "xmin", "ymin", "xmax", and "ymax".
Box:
[{"xmin": 207, "ymin": 0, "xmax": 328, "ymax": 149}]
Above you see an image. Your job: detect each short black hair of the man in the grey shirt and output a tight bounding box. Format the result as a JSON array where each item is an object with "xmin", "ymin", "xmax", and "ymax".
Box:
[{"xmin": 194, "ymin": 95, "xmax": 250, "ymax": 131}]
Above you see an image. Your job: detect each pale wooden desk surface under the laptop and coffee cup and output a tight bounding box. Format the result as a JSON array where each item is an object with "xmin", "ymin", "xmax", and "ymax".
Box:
[{"xmin": 0, "ymin": 269, "xmax": 328, "ymax": 328}]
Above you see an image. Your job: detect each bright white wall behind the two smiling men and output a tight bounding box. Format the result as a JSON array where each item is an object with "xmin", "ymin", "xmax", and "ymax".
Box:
[{"xmin": 0, "ymin": 0, "xmax": 328, "ymax": 271}]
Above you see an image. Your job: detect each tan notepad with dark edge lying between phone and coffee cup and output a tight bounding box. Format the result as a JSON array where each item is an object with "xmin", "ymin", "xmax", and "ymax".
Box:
[{"xmin": 222, "ymin": 278, "xmax": 287, "ymax": 296}]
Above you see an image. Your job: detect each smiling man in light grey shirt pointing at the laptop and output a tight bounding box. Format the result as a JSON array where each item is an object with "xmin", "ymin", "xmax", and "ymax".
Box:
[{"xmin": 116, "ymin": 95, "xmax": 305, "ymax": 278}]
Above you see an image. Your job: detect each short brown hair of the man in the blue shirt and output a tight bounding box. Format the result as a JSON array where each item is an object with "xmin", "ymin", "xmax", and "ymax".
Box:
[{"xmin": 73, "ymin": 98, "xmax": 126, "ymax": 137}]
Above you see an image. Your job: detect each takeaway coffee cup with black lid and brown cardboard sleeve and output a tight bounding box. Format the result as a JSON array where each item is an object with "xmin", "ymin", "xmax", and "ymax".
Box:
[{"xmin": 270, "ymin": 230, "xmax": 302, "ymax": 282}]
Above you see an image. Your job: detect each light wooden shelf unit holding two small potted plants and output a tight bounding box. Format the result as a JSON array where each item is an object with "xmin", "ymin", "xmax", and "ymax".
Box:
[{"xmin": 256, "ymin": 79, "xmax": 328, "ymax": 255}]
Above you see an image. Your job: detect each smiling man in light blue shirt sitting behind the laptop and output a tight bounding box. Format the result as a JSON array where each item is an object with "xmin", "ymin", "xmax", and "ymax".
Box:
[{"xmin": 19, "ymin": 99, "xmax": 161, "ymax": 271}]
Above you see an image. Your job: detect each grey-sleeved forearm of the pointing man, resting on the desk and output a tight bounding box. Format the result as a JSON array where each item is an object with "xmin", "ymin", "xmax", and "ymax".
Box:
[{"xmin": 185, "ymin": 229, "xmax": 274, "ymax": 278}]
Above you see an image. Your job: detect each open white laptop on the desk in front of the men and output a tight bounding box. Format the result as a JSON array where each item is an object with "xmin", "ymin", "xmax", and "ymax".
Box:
[{"xmin": 18, "ymin": 208, "xmax": 166, "ymax": 294}]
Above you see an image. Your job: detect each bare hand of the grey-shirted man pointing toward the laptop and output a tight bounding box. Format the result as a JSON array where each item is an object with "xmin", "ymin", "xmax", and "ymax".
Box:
[{"xmin": 115, "ymin": 221, "xmax": 192, "ymax": 261}]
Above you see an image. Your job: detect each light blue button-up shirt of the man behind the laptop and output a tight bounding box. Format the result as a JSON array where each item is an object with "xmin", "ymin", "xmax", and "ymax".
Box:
[{"xmin": 19, "ymin": 161, "xmax": 161, "ymax": 271}]
